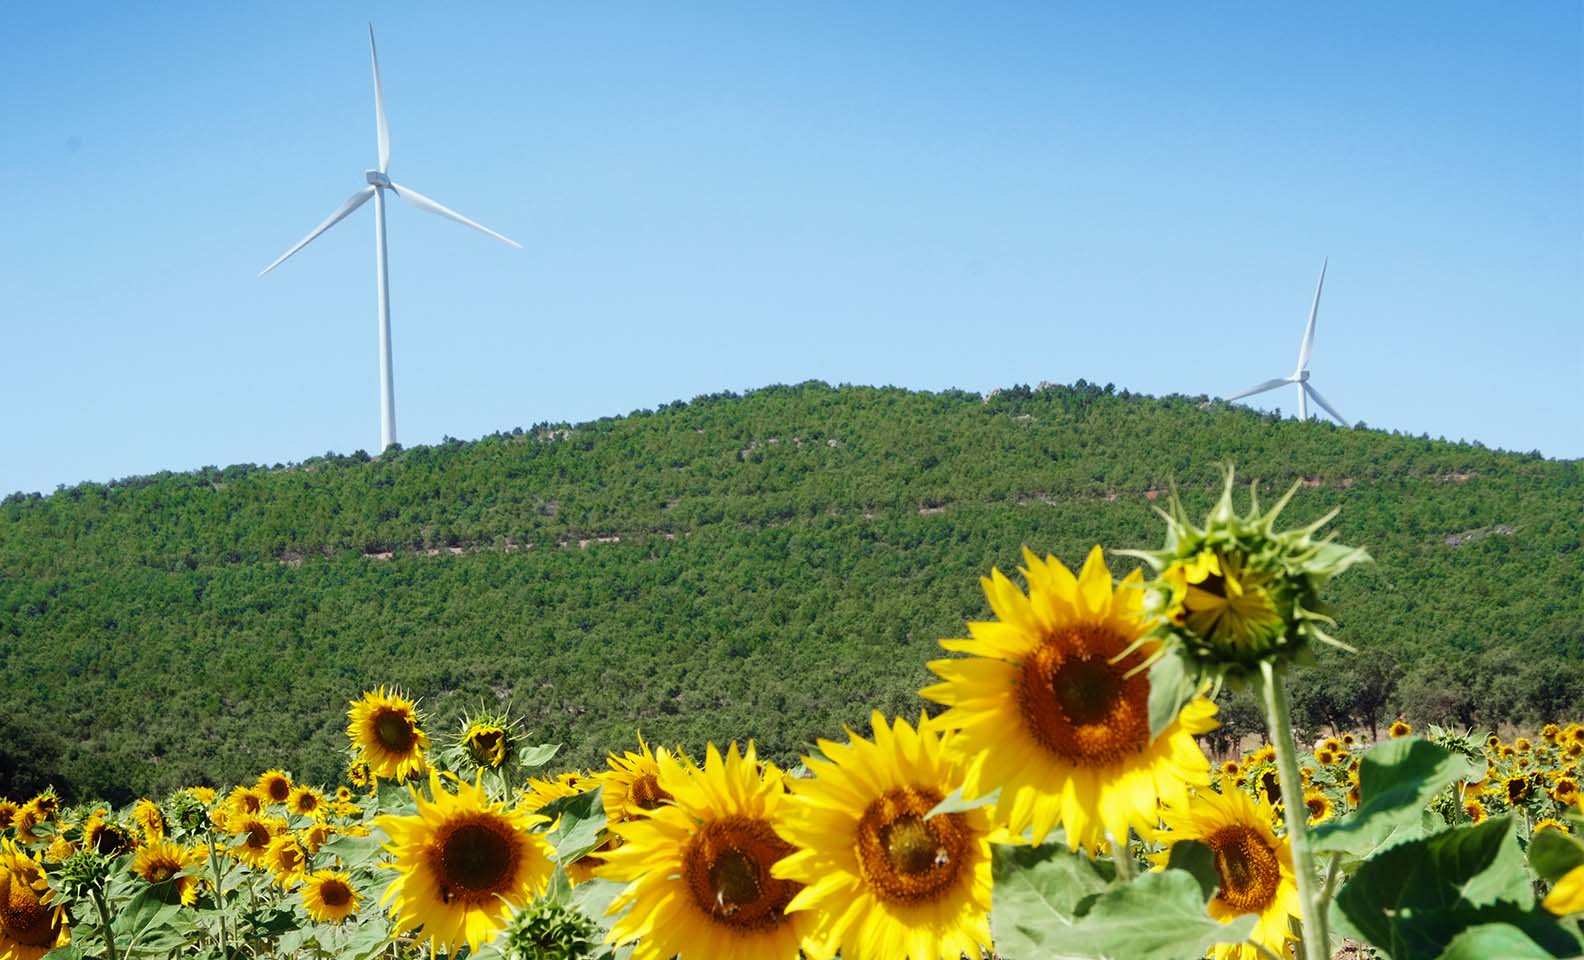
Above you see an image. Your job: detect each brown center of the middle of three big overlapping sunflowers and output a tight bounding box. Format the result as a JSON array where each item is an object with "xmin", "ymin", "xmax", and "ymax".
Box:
[{"xmin": 857, "ymin": 787, "xmax": 973, "ymax": 905}]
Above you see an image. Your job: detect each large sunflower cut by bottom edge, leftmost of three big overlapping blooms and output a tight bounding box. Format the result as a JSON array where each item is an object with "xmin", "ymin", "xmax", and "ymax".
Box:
[{"xmin": 596, "ymin": 743, "xmax": 814, "ymax": 960}]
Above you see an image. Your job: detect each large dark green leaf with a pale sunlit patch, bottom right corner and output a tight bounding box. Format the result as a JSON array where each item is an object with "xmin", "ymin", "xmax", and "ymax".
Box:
[{"xmin": 1334, "ymin": 817, "xmax": 1578, "ymax": 960}]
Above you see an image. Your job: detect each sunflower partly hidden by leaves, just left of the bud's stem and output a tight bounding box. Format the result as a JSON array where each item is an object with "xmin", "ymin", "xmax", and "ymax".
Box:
[{"xmin": 1152, "ymin": 790, "xmax": 1302, "ymax": 960}]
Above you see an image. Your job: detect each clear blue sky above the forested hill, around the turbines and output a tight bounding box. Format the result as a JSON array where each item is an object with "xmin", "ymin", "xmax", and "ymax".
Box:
[{"xmin": 0, "ymin": 2, "xmax": 1584, "ymax": 493}]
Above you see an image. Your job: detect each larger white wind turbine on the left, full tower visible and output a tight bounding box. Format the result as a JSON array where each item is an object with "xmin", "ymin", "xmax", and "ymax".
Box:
[{"xmin": 258, "ymin": 24, "xmax": 523, "ymax": 451}]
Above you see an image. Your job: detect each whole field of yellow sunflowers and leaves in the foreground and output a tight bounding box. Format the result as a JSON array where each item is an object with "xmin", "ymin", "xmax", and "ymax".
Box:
[{"xmin": 0, "ymin": 470, "xmax": 1584, "ymax": 960}]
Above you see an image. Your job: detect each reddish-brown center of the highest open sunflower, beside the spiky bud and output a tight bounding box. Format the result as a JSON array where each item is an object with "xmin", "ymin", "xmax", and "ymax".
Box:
[{"xmin": 1017, "ymin": 626, "xmax": 1150, "ymax": 767}]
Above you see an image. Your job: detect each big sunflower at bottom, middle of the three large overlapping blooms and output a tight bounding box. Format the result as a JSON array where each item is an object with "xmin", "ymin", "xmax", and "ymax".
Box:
[{"xmin": 771, "ymin": 713, "xmax": 992, "ymax": 960}]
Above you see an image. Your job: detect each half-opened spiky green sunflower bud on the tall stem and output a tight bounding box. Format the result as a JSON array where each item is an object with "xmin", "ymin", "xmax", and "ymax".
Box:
[{"xmin": 1125, "ymin": 467, "xmax": 1369, "ymax": 680}]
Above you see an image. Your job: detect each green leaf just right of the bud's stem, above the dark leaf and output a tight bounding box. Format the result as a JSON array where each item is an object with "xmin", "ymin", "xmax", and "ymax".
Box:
[{"xmin": 1310, "ymin": 737, "xmax": 1484, "ymax": 859}]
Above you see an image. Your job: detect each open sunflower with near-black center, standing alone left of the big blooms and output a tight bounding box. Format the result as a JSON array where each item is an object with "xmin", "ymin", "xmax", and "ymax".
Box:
[{"xmin": 375, "ymin": 770, "xmax": 554, "ymax": 952}]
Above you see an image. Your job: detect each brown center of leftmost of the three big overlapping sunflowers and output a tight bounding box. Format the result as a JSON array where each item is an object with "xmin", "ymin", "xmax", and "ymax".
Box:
[{"xmin": 683, "ymin": 816, "xmax": 803, "ymax": 930}]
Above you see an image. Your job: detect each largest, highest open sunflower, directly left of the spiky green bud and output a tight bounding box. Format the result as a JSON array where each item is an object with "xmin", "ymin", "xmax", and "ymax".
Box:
[{"xmin": 920, "ymin": 547, "xmax": 1217, "ymax": 855}]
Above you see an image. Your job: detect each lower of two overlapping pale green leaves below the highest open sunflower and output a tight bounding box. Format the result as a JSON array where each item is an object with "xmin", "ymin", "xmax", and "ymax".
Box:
[{"xmin": 1014, "ymin": 870, "xmax": 1258, "ymax": 960}]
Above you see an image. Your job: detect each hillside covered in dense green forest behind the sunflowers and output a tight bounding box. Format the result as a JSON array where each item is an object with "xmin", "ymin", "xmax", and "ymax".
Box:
[{"xmin": 0, "ymin": 382, "xmax": 1584, "ymax": 800}]
